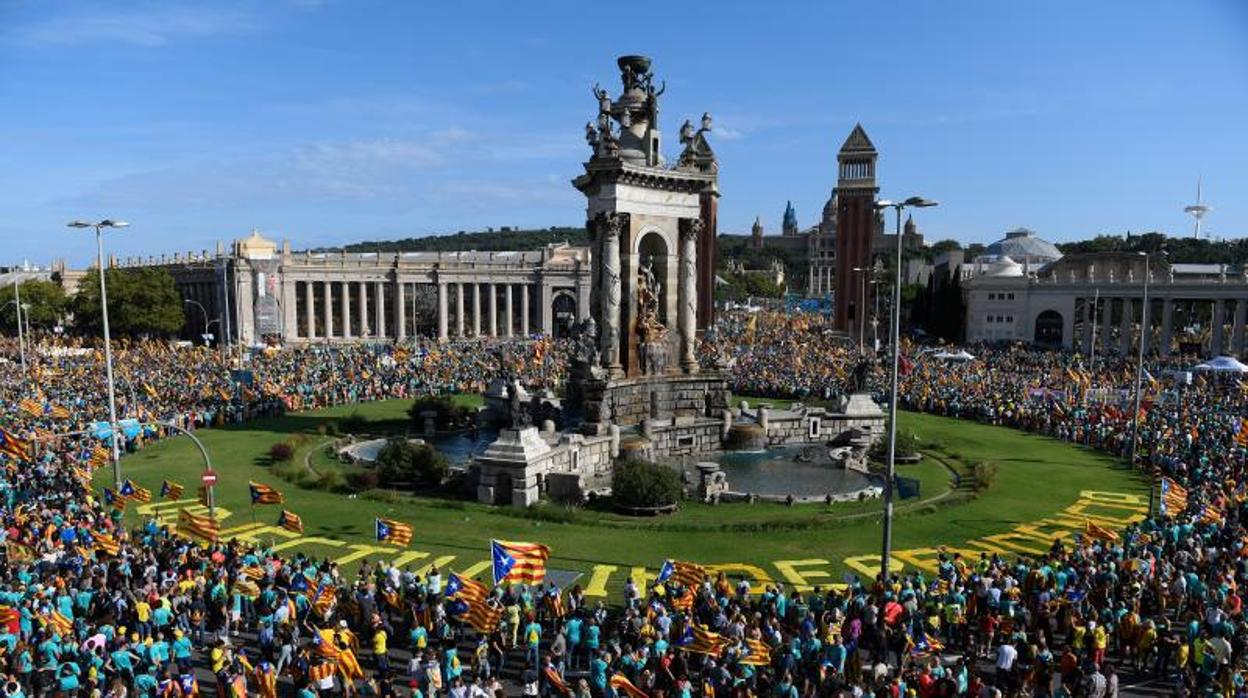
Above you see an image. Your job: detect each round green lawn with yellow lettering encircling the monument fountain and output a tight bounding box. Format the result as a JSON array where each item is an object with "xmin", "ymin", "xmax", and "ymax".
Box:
[{"xmin": 96, "ymin": 396, "xmax": 1144, "ymax": 599}]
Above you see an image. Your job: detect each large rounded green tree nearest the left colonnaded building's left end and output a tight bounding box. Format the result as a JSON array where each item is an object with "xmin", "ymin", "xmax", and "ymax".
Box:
[{"xmin": 72, "ymin": 267, "xmax": 184, "ymax": 337}]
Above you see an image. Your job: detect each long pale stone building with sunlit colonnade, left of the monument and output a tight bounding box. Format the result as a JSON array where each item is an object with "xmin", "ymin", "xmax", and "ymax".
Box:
[{"xmin": 115, "ymin": 231, "xmax": 590, "ymax": 345}]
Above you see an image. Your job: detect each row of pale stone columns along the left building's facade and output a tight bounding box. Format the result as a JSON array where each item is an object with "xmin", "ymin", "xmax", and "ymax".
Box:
[{"xmin": 287, "ymin": 280, "xmax": 589, "ymax": 340}]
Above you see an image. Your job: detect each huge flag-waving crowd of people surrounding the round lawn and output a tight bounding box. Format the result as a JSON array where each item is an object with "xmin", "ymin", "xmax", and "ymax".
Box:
[{"xmin": 0, "ymin": 313, "xmax": 1248, "ymax": 698}]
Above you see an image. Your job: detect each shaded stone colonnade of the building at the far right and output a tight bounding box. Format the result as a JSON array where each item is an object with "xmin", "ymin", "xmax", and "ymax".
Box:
[{"xmin": 1073, "ymin": 296, "xmax": 1248, "ymax": 357}]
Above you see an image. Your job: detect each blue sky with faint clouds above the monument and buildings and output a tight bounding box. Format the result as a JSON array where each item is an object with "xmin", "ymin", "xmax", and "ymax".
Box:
[{"xmin": 0, "ymin": 0, "xmax": 1248, "ymax": 263}]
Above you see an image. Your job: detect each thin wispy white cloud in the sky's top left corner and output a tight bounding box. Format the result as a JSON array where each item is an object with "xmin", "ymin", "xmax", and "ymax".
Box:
[{"xmin": 15, "ymin": 5, "xmax": 258, "ymax": 46}]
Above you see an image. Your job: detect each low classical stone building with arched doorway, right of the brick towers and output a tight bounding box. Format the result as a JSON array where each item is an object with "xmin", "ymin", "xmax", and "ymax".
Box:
[{"xmin": 966, "ymin": 245, "xmax": 1248, "ymax": 357}]
